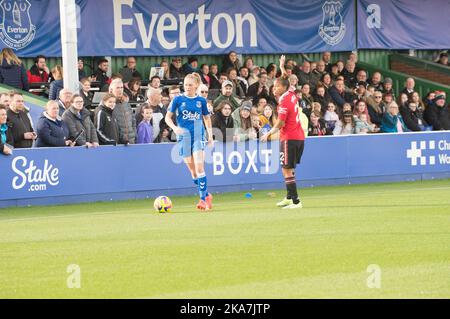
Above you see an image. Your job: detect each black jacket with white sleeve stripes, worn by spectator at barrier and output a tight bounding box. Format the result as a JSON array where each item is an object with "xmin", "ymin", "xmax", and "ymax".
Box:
[{"xmin": 95, "ymin": 104, "xmax": 121, "ymax": 145}]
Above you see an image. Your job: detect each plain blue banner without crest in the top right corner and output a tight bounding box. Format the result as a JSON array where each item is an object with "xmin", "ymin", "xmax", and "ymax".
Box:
[{"xmin": 358, "ymin": 0, "xmax": 450, "ymax": 49}]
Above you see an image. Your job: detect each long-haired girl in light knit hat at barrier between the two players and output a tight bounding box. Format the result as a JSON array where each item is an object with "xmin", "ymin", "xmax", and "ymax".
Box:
[{"xmin": 231, "ymin": 101, "xmax": 257, "ymax": 142}]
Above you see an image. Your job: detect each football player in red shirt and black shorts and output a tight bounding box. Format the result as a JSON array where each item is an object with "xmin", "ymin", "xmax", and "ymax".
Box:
[{"xmin": 261, "ymin": 78, "xmax": 305, "ymax": 209}]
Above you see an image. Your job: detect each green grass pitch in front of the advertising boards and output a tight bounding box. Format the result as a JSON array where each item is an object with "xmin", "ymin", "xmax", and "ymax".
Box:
[{"xmin": 0, "ymin": 180, "xmax": 450, "ymax": 298}]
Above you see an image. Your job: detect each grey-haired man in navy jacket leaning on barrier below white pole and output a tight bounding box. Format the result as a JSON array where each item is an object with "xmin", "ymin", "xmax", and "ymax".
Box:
[{"xmin": 36, "ymin": 100, "xmax": 75, "ymax": 147}]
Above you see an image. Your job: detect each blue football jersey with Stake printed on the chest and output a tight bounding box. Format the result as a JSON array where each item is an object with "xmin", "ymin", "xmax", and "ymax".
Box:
[{"xmin": 169, "ymin": 94, "xmax": 209, "ymax": 137}]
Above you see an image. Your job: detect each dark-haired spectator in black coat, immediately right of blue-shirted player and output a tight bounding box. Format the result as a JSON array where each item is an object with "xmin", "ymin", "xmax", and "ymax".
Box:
[{"xmin": 212, "ymin": 101, "xmax": 234, "ymax": 143}]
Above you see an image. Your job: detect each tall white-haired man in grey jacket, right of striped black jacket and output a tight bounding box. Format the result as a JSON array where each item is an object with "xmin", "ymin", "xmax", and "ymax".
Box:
[{"xmin": 109, "ymin": 79, "xmax": 136, "ymax": 144}]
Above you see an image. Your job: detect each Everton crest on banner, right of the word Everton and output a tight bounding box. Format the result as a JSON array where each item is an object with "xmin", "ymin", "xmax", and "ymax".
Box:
[{"xmin": 319, "ymin": 1, "xmax": 346, "ymax": 45}]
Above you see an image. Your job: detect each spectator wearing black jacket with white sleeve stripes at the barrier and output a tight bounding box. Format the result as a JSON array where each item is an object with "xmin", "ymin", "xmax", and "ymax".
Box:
[{"xmin": 94, "ymin": 93, "xmax": 120, "ymax": 145}]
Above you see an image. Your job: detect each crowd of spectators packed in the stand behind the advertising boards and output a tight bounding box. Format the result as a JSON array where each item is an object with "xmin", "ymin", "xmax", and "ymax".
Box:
[{"xmin": 0, "ymin": 49, "xmax": 450, "ymax": 154}]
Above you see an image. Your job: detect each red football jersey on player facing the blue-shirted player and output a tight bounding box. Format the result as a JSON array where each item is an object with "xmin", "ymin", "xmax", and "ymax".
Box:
[{"xmin": 277, "ymin": 91, "xmax": 305, "ymax": 141}]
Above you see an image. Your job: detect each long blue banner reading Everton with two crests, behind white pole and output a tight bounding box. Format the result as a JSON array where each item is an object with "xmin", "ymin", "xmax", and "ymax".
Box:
[{"xmin": 0, "ymin": 0, "xmax": 356, "ymax": 57}]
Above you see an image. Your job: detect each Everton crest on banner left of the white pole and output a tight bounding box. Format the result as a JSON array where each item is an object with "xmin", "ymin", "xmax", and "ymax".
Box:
[{"xmin": 0, "ymin": 0, "xmax": 36, "ymax": 50}]
